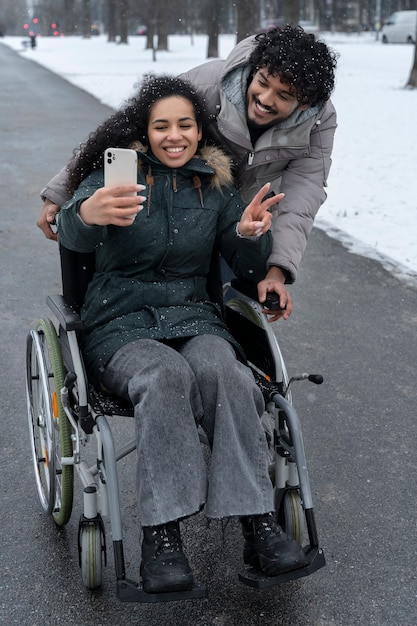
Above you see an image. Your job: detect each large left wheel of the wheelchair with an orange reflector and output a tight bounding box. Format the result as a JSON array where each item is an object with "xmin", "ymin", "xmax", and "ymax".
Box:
[{"xmin": 26, "ymin": 319, "xmax": 74, "ymax": 526}]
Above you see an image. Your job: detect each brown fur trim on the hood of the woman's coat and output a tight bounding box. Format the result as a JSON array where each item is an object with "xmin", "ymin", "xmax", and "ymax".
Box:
[{"xmin": 130, "ymin": 141, "xmax": 233, "ymax": 190}]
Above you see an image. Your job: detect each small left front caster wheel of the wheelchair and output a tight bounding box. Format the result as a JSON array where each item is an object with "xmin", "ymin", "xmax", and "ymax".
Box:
[{"xmin": 79, "ymin": 522, "xmax": 103, "ymax": 589}]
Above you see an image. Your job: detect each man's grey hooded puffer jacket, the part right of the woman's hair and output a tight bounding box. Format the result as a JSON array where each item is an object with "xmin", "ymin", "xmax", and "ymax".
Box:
[{"xmin": 182, "ymin": 37, "xmax": 337, "ymax": 282}]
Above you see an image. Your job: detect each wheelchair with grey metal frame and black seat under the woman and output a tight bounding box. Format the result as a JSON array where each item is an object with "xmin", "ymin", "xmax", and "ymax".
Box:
[{"xmin": 26, "ymin": 246, "xmax": 325, "ymax": 603}]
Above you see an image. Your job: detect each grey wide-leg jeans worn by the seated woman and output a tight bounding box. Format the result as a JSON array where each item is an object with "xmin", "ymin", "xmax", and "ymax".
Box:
[{"xmin": 103, "ymin": 335, "xmax": 274, "ymax": 526}]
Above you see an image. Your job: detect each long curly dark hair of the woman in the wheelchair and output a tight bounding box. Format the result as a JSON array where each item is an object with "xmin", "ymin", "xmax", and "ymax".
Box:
[{"xmin": 67, "ymin": 74, "xmax": 208, "ymax": 194}]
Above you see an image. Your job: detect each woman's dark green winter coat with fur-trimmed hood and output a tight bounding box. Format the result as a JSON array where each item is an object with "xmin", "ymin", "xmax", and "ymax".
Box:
[{"xmin": 58, "ymin": 147, "xmax": 271, "ymax": 383}]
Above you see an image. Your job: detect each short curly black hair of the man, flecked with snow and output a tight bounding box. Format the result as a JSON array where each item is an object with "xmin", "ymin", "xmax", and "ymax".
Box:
[{"xmin": 249, "ymin": 24, "xmax": 339, "ymax": 106}]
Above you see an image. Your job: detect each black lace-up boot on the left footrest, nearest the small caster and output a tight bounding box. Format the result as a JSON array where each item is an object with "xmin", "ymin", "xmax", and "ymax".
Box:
[{"xmin": 140, "ymin": 521, "xmax": 194, "ymax": 593}]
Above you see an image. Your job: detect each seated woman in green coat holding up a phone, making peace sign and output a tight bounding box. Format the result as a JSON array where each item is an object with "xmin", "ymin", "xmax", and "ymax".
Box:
[{"xmin": 58, "ymin": 76, "xmax": 307, "ymax": 593}]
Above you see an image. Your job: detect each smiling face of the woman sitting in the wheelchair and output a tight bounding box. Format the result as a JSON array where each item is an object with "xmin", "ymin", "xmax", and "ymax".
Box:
[{"xmin": 148, "ymin": 96, "xmax": 201, "ymax": 168}]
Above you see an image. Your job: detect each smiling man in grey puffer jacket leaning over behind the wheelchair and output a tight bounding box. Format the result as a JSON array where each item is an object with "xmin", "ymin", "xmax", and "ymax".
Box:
[{"xmin": 38, "ymin": 25, "xmax": 337, "ymax": 320}]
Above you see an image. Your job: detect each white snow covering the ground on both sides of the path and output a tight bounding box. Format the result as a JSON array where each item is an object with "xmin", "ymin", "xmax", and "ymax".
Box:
[{"xmin": 0, "ymin": 33, "xmax": 417, "ymax": 285}]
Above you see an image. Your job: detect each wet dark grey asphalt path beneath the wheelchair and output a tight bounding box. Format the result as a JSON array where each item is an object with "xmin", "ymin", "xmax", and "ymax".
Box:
[{"xmin": 0, "ymin": 45, "xmax": 417, "ymax": 626}]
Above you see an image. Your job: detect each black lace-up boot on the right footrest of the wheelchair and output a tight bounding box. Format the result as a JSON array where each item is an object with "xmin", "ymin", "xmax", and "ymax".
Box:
[{"xmin": 240, "ymin": 513, "xmax": 308, "ymax": 576}]
